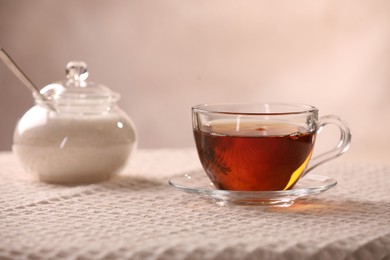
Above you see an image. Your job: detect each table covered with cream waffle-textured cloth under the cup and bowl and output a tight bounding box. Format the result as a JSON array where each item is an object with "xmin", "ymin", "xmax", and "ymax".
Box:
[{"xmin": 0, "ymin": 149, "xmax": 390, "ymax": 260}]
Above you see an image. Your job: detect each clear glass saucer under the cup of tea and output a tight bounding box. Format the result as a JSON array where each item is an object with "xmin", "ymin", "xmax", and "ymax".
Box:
[{"xmin": 169, "ymin": 171, "xmax": 337, "ymax": 207}]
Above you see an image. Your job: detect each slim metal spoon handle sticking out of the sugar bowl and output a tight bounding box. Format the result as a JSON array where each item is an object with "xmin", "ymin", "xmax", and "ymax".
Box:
[{"xmin": 0, "ymin": 47, "xmax": 56, "ymax": 111}]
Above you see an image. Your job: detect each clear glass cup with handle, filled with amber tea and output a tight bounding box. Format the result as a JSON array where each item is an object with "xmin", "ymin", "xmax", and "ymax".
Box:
[{"xmin": 192, "ymin": 103, "xmax": 351, "ymax": 191}]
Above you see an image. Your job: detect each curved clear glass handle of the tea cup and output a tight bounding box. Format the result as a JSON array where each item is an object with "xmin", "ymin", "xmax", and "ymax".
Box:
[{"xmin": 303, "ymin": 115, "xmax": 352, "ymax": 176}]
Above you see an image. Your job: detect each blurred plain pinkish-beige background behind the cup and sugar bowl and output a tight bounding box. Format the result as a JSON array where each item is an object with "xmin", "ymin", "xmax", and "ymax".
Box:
[{"xmin": 0, "ymin": 0, "xmax": 390, "ymax": 163}]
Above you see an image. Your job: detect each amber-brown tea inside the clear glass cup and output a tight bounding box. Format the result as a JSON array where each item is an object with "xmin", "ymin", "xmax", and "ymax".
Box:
[{"xmin": 194, "ymin": 122, "xmax": 316, "ymax": 191}]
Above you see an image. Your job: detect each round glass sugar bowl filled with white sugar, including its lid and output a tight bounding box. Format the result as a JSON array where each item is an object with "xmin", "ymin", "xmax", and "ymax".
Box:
[{"xmin": 12, "ymin": 61, "xmax": 137, "ymax": 184}]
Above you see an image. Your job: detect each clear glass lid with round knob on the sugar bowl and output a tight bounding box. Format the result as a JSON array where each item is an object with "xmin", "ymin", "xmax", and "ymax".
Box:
[{"xmin": 34, "ymin": 61, "xmax": 120, "ymax": 105}]
